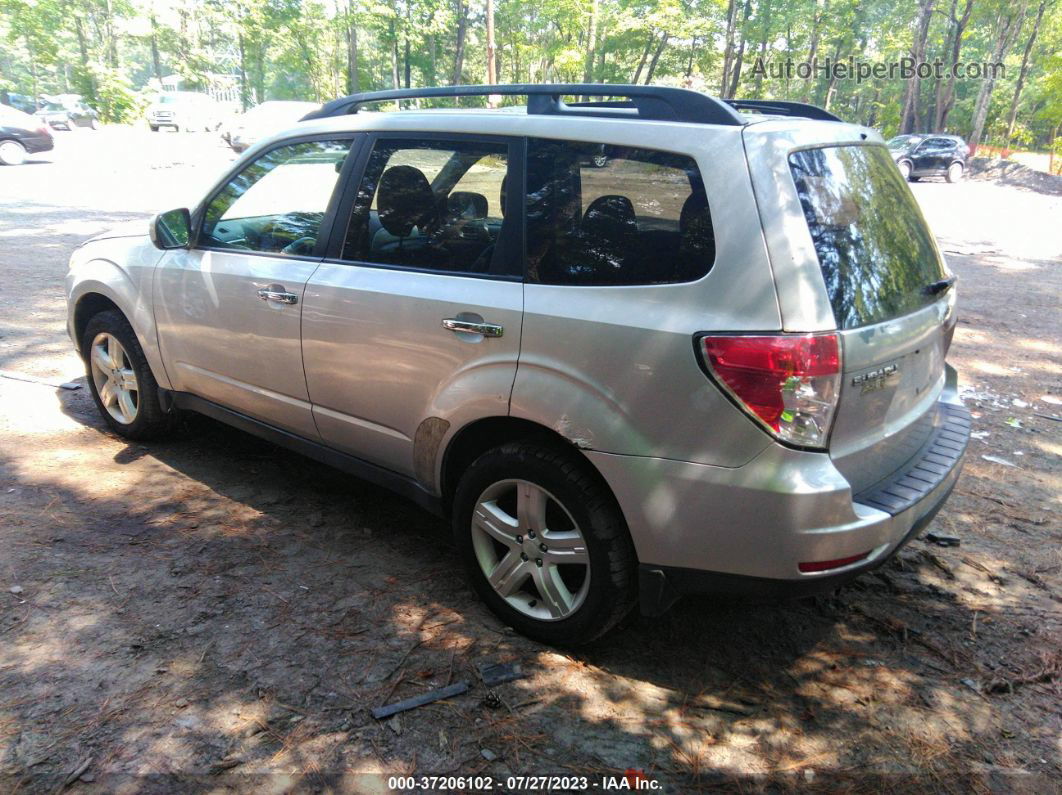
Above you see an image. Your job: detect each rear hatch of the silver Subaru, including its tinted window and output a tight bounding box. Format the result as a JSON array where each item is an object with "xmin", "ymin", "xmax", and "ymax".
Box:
[{"xmin": 788, "ymin": 145, "xmax": 955, "ymax": 492}]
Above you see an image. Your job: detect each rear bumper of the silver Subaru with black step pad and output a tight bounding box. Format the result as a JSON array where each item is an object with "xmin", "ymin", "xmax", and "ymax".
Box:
[{"xmin": 588, "ymin": 368, "xmax": 970, "ymax": 615}]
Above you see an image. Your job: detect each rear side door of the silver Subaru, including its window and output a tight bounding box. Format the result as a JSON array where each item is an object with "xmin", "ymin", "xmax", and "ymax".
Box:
[{"xmin": 303, "ymin": 136, "xmax": 523, "ymax": 480}]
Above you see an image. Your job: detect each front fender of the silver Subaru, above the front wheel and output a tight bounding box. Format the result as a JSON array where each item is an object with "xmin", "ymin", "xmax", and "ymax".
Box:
[{"xmin": 67, "ymin": 242, "xmax": 170, "ymax": 390}]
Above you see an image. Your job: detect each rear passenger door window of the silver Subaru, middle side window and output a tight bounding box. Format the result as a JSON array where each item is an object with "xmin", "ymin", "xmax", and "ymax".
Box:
[{"xmin": 343, "ymin": 138, "xmax": 509, "ymax": 273}]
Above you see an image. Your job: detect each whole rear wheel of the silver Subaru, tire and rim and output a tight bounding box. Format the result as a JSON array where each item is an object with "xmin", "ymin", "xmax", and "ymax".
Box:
[{"xmin": 453, "ymin": 442, "xmax": 637, "ymax": 645}]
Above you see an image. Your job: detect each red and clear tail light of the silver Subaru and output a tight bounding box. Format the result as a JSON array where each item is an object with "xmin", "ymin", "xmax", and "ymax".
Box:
[{"xmin": 699, "ymin": 333, "xmax": 841, "ymax": 448}]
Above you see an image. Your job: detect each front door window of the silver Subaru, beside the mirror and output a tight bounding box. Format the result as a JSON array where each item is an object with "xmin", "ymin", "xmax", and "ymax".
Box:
[{"xmin": 199, "ymin": 141, "xmax": 350, "ymax": 256}]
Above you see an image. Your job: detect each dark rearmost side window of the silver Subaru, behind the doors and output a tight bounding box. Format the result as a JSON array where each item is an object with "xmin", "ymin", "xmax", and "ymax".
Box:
[{"xmin": 527, "ymin": 138, "xmax": 716, "ymax": 286}]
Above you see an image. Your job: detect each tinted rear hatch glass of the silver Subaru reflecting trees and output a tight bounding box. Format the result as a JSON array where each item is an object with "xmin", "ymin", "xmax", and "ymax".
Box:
[{"xmin": 789, "ymin": 145, "xmax": 944, "ymax": 329}]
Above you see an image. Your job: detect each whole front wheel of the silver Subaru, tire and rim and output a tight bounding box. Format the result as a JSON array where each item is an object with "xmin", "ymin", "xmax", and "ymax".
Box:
[{"xmin": 81, "ymin": 310, "xmax": 176, "ymax": 439}]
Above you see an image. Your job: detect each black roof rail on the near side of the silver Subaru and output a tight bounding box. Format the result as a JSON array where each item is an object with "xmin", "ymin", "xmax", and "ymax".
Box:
[{"xmin": 303, "ymin": 83, "xmax": 746, "ymax": 125}]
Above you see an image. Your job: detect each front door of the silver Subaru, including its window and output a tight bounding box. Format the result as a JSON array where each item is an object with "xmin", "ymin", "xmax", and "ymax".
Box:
[{"xmin": 155, "ymin": 134, "xmax": 350, "ymax": 438}]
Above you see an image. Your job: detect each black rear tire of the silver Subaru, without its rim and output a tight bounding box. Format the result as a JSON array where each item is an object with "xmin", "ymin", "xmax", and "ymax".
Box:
[{"xmin": 452, "ymin": 440, "xmax": 637, "ymax": 646}]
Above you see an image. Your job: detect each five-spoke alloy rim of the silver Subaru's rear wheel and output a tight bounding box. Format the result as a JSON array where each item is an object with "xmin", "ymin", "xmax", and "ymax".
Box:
[{"xmin": 472, "ymin": 480, "xmax": 590, "ymax": 621}]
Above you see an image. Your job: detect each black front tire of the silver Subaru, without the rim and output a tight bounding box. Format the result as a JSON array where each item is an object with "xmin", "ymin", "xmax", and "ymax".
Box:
[{"xmin": 81, "ymin": 310, "xmax": 177, "ymax": 440}]
